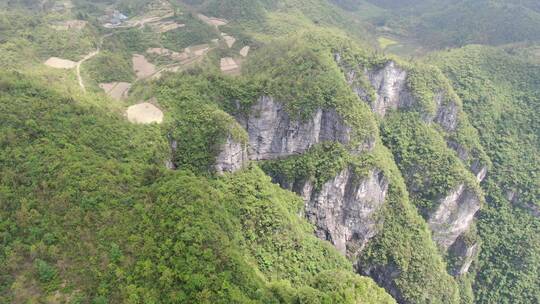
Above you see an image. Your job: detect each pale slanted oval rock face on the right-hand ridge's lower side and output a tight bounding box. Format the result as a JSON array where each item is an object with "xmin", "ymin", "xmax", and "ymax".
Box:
[{"xmin": 428, "ymin": 184, "xmax": 480, "ymax": 249}]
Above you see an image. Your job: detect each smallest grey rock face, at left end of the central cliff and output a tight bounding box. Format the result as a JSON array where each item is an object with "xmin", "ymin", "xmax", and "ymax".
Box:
[{"xmin": 215, "ymin": 135, "xmax": 248, "ymax": 174}]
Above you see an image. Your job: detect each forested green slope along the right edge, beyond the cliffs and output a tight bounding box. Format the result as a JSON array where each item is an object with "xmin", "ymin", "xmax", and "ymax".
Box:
[{"xmin": 431, "ymin": 46, "xmax": 540, "ymax": 303}]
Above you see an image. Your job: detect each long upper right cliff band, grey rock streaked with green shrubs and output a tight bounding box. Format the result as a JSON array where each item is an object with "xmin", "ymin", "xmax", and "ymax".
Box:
[{"xmin": 342, "ymin": 59, "xmax": 488, "ymax": 176}]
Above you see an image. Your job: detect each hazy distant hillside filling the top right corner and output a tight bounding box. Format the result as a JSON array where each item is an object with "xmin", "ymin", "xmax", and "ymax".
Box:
[{"xmin": 332, "ymin": 0, "xmax": 540, "ymax": 55}]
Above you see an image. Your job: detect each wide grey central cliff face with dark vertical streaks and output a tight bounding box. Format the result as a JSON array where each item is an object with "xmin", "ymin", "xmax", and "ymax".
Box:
[{"xmin": 237, "ymin": 96, "xmax": 363, "ymax": 160}]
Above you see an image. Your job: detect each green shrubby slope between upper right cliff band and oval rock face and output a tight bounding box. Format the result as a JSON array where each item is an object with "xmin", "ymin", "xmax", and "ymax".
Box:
[{"xmin": 381, "ymin": 113, "xmax": 481, "ymax": 218}]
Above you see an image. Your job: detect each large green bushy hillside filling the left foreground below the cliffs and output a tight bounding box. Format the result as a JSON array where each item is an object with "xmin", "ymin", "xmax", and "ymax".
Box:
[{"xmin": 0, "ymin": 73, "xmax": 393, "ymax": 303}]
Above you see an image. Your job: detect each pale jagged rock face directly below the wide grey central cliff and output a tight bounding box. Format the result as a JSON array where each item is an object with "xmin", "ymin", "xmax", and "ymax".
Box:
[{"xmin": 299, "ymin": 168, "xmax": 388, "ymax": 258}]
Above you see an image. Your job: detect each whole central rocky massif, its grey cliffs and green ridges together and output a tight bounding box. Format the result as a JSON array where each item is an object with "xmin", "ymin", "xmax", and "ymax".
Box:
[{"xmin": 206, "ymin": 33, "xmax": 489, "ymax": 303}]
